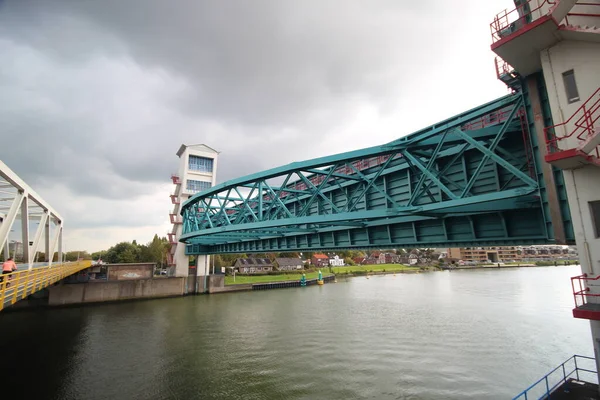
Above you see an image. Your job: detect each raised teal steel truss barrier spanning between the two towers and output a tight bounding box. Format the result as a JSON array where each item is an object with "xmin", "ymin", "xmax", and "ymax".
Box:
[{"xmin": 180, "ymin": 93, "xmax": 572, "ymax": 254}]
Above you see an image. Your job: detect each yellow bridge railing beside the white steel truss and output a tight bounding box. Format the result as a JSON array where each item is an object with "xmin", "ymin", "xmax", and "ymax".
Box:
[{"xmin": 0, "ymin": 261, "xmax": 91, "ymax": 310}]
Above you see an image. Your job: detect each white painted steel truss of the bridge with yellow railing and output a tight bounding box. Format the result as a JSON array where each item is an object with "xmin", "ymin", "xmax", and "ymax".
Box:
[{"xmin": 0, "ymin": 161, "xmax": 64, "ymax": 269}]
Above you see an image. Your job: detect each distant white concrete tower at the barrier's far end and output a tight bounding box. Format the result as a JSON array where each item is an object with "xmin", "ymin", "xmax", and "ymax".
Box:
[{"xmin": 168, "ymin": 144, "xmax": 219, "ymax": 276}]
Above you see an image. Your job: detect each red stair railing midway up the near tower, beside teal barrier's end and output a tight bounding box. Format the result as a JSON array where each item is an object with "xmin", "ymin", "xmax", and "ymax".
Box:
[{"xmin": 544, "ymin": 88, "xmax": 600, "ymax": 157}]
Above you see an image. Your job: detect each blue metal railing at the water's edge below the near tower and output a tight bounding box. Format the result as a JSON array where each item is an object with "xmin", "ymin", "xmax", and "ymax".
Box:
[{"xmin": 513, "ymin": 354, "xmax": 597, "ymax": 400}]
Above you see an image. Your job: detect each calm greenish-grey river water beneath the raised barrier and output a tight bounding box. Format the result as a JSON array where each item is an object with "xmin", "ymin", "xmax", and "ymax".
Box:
[{"xmin": 0, "ymin": 266, "xmax": 593, "ymax": 400}]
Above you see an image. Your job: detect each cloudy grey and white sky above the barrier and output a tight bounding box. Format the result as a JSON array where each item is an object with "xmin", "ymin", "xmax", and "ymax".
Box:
[{"xmin": 0, "ymin": 0, "xmax": 514, "ymax": 252}]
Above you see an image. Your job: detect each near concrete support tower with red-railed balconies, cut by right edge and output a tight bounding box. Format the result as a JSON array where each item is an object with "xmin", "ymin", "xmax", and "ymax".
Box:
[{"xmin": 491, "ymin": 0, "xmax": 600, "ymax": 371}]
